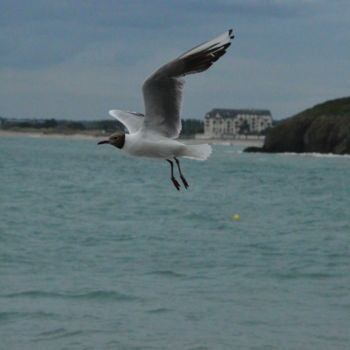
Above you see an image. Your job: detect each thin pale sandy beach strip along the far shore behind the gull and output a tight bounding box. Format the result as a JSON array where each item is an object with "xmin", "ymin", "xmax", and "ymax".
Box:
[{"xmin": 0, "ymin": 130, "xmax": 264, "ymax": 147}]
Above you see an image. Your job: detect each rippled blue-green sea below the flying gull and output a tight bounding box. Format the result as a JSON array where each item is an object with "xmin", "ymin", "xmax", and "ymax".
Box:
[{"xmin": 0, "ymin": 137, "xmax": 350, "ymax": 350}]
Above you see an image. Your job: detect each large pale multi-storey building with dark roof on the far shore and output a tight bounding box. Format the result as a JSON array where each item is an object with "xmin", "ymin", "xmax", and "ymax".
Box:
[{"xmin": 203, "ymin": 108, "xmax": 272, "ymax": 138}]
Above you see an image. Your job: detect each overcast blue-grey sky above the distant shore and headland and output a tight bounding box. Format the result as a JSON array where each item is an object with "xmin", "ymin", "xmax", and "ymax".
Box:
[{"xmin": 0, "ymin": 0, "xmax": 350, "ymax": 120}]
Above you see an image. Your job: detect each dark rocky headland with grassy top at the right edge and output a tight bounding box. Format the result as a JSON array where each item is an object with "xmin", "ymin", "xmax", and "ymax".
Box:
[{"xmin": 245, "ymin": 97, "xmax": 350, "ymax": 154}]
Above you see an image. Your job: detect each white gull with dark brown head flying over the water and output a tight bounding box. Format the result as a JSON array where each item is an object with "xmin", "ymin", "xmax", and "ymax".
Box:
[{"xmin": 98, "ymin": 29, "xmax": 234, "ymax": 190}]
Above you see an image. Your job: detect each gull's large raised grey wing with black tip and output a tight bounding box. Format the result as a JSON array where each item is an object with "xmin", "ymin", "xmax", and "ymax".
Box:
[{"xmin": 142, "ymin": 29, "xmax": 234, "ymax": 138}]
